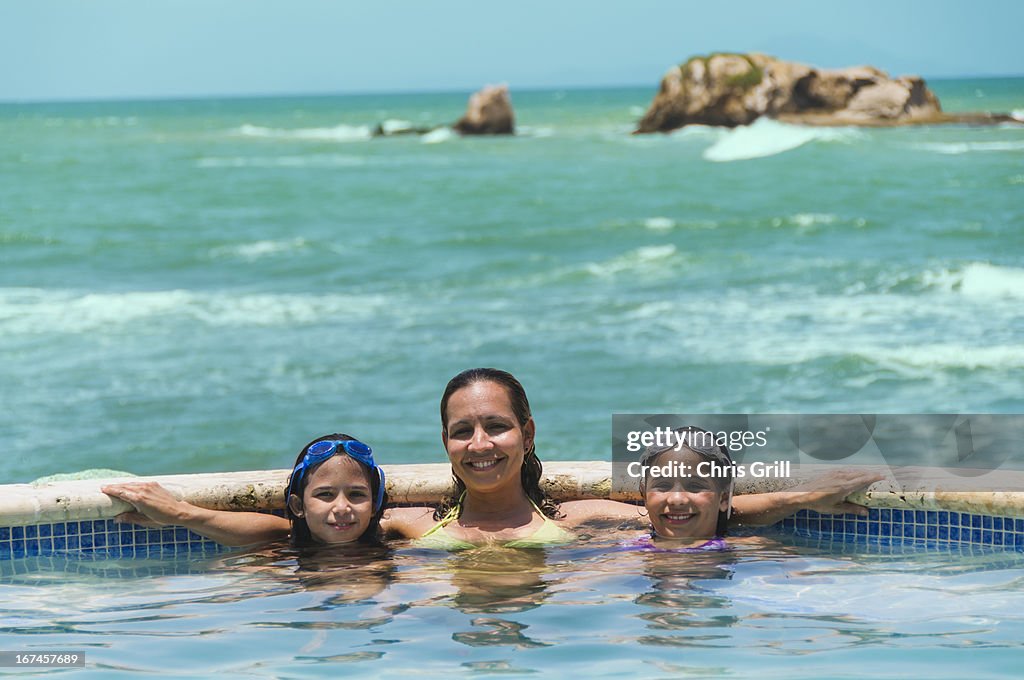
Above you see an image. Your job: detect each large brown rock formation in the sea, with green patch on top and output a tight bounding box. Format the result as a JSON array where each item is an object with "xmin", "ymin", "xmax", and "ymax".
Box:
[{"xmin": 636, "ymin": 52, "xmax": 1014, "ymax": 133}]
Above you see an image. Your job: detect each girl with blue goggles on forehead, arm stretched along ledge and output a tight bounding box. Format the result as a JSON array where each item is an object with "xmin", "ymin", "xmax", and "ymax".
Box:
[{"xmin": 101, "ymin": 433, "xmax": 387, "ymax": 548}]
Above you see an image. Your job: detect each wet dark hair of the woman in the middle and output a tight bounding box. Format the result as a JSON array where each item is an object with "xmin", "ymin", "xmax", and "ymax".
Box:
[{"xmin": 434, "ymin": 369, "xmax": 561, "ymax": 521}]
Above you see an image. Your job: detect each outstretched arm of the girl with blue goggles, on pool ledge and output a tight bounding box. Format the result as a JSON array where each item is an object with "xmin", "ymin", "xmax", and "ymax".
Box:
[{"xmin": 100, "ymin": 481, "xmax": 291, "ymax": 546}]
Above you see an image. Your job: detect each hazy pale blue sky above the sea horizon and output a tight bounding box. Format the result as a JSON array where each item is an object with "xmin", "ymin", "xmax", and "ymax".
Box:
[{"xmin": 0, "ymin": 0, "xmax": 1024, "ymax": 101}]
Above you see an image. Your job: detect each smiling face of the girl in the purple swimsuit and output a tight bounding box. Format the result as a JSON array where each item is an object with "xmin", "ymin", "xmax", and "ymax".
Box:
[{"xmin": 644, "ymin": 449, "xmax": 729, "ymax": 540}]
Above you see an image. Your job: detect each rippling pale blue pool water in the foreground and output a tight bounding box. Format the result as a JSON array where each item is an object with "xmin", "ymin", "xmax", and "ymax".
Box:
[{"xmin": 0, "ymin": 530, "xmax": 1024, "ymax": 678}]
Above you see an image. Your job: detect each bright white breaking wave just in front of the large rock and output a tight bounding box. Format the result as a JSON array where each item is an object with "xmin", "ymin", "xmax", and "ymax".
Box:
[{"xmin": 703, "ymin": 118, "xmax": 864, "ymax": 162}]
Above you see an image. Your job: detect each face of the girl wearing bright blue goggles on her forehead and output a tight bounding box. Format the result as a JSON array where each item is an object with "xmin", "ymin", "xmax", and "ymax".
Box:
[{"xmin": 288, "ymin": 454, "xmax": 374, "ymax": 544}]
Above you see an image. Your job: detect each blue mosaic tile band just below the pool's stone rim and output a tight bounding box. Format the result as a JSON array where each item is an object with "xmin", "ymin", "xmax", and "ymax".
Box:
[{"xmin": 6, "ymin": 508, "xmax": 1024, "ymax": 559}]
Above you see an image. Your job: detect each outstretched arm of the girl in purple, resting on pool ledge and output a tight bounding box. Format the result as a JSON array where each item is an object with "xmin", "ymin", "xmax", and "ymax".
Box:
[{"xmin": 730, "ymin": 469, "xmax": 885, "ymax": 526}]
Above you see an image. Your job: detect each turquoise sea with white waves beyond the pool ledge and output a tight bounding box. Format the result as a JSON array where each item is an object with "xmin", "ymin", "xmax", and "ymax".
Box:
[{"xmin": 0, "ymin": 79, "xmax": 1024, "ymax": 482}]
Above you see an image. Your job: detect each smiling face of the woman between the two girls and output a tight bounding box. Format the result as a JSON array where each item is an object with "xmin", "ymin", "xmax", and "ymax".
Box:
[{"xmin": 441, "ymin": 381, "xmax": 535, "ymax": 493}]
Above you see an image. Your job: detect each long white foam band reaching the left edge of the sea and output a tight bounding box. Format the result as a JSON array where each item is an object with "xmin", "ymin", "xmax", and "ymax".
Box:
[{"xmin": 0, "ymin": 288, "xmax": 392, "ymax": 335}]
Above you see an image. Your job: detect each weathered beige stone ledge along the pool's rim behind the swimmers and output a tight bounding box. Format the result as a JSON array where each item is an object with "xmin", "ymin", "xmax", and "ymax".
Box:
[{"xmin": 0, "ymin": 461, "xmax": 1024, "ymax": 526}]
